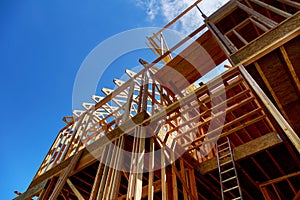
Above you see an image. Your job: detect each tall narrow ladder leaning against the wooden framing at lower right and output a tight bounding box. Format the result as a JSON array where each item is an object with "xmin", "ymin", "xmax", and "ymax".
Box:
[{"xmin": 216, "ymin": 137, "xmax": 243, "ymax": 200}]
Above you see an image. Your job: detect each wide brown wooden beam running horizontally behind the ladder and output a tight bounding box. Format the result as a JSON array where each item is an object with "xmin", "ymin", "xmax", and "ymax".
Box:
[{"xmin": 200, "ymin": 133, "xmax": 282, "ymax": 174}]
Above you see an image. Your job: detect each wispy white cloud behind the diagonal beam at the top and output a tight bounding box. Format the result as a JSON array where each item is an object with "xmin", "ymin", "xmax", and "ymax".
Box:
[{"xmin": 135, "ymin": 0, "xmax": 229, "ymax": 34}]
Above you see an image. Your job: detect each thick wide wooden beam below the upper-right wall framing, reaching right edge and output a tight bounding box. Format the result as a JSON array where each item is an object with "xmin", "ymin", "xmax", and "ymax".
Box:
[{"xmin": 230, "ymin": 12, "xmax": 300, "ymax": 66}]
